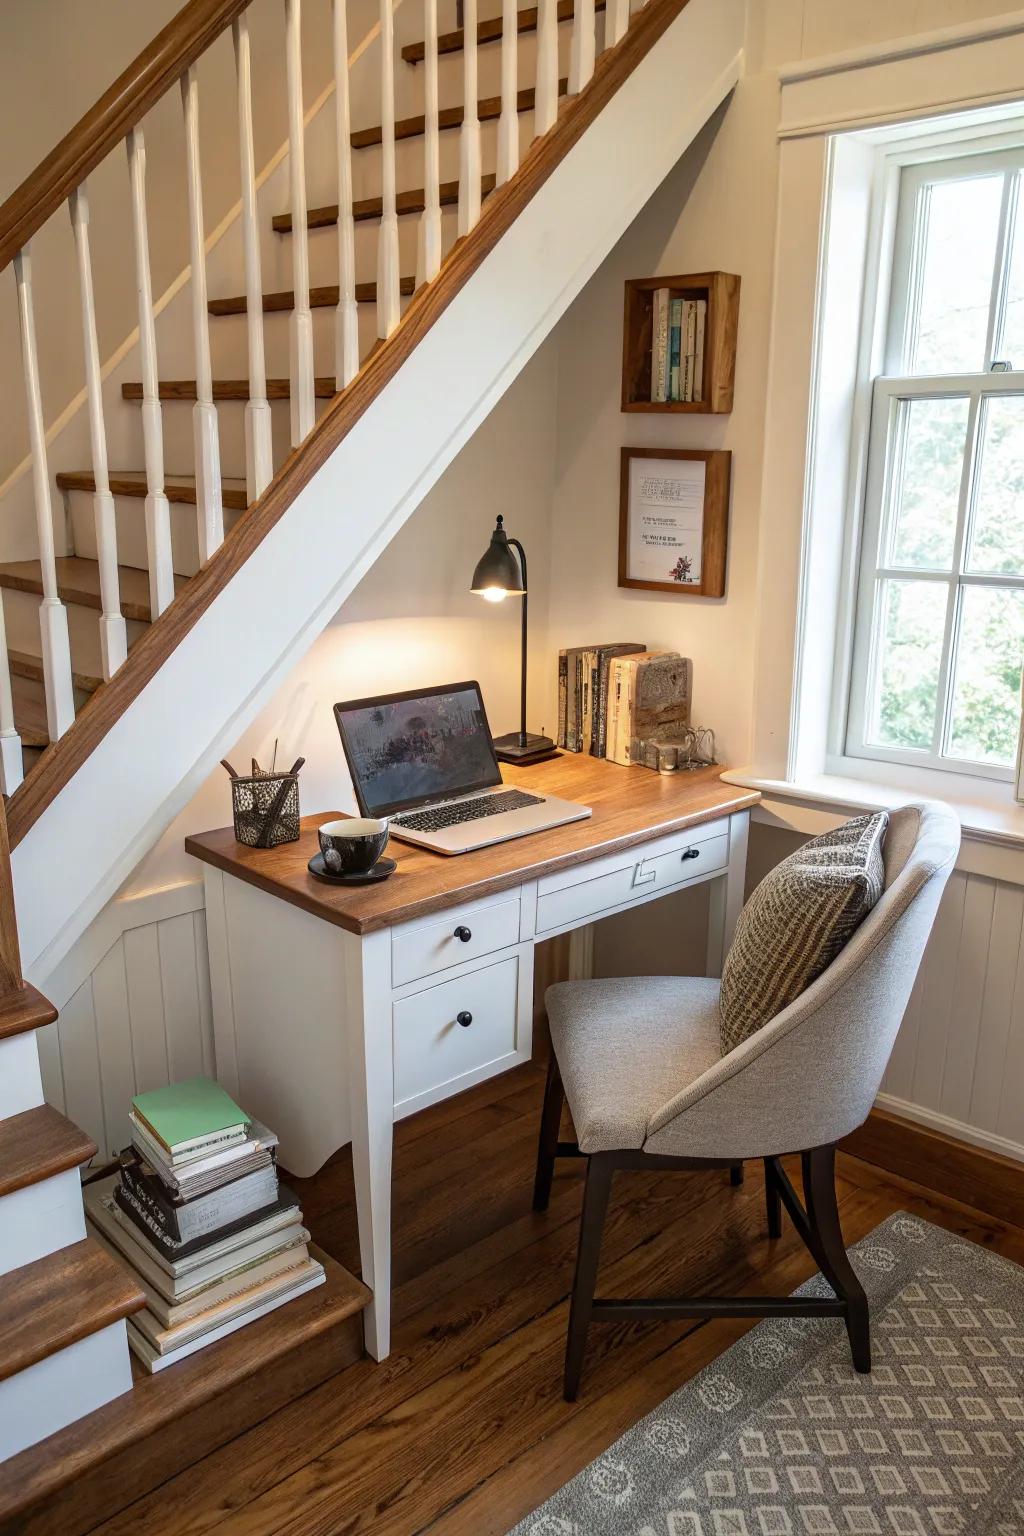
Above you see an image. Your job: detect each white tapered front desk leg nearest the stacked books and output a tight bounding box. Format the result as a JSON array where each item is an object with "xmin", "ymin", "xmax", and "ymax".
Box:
[{"xmin": 344, "ymin": 929, "xmax": 395, "ymax": 1359}]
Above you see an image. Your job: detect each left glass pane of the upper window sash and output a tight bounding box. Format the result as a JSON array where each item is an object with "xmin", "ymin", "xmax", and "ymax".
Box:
[{"xmin": 909, "ymin": 175, "xmax": 1003, "ymax": 373}]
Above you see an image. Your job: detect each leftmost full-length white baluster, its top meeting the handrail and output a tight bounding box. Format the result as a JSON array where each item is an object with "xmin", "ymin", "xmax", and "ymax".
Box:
[{"xmin": 12, "ymin": 246, "xmax": 75, "ymax": 742}]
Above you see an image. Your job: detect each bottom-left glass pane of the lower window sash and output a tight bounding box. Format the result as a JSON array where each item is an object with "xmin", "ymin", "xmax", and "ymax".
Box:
[{"xmin": 867, "ymin": 581, "xmax": 947, "ymax": 750}]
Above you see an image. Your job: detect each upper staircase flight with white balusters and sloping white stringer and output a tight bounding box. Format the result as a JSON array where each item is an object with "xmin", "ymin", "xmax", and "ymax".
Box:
[{"xmin": 0, "ymin": 0, "xmax": 745, "ymax": 975}]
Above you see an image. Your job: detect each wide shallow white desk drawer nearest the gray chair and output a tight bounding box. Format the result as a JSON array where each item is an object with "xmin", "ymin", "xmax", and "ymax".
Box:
[{"xmin": 537, "ymin": 822, "xmax": 729, "ymax": 934}]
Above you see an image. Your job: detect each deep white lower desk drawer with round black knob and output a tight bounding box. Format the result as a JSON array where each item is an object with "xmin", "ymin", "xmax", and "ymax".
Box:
[{"xmin": 391, "ymin": 955, "xmax": 519, "ymax": 1112}]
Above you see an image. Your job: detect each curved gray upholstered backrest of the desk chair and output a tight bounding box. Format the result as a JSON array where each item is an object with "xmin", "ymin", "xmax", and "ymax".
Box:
[{"xmin": 645, "ymin": 800, "xmax": 960, "ymax": 1157}]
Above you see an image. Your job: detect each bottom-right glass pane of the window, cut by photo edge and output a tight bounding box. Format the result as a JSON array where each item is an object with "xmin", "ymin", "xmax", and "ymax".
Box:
[{"xmin": 947, "ymin": 587, "xmax": 1024, "ymax": 766}]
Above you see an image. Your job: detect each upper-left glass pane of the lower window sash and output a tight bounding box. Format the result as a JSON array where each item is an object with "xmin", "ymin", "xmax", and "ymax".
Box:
[{"xmin": 889, "ymin": 396, "xmax": 970, "ymax": 570}]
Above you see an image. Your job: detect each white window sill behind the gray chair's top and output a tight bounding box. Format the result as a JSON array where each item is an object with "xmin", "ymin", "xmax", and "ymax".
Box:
[{"xmin": 722, "ymin": 768, "xmax": 1024, "ymax": 852}]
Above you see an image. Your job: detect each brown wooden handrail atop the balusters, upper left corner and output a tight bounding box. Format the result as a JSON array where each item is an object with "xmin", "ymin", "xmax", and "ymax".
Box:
[{"xmin": 0, "ymin": 0, "xmax": 250, "ymax": 272}]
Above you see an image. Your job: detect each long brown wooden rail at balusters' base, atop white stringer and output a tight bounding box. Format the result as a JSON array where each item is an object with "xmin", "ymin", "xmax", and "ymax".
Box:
[{"xmin": 8, "ymin": 0, "xmax": 689, "ymax": 848}]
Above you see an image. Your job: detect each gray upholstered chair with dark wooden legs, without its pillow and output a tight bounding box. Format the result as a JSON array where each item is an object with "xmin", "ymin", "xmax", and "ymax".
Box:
[{"xmin": 534, "ymin": 802, "xmax": 960, "ymax": 1401}]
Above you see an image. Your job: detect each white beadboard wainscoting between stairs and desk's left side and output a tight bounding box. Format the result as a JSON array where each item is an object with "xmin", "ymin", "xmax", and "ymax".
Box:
[{"xmin": 32, "ymin": 880, "xmax": 215, "ymax": 1160}]
